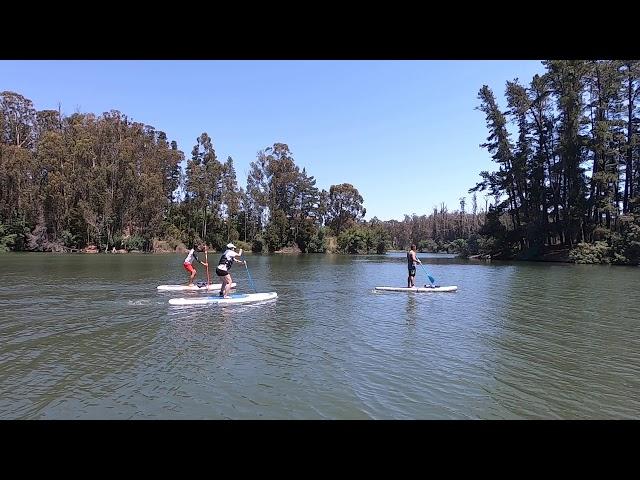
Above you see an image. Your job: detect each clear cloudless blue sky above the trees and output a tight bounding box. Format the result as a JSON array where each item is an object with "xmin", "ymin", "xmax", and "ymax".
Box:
[{"xmin": 0, "ymin": 60, "xmax": 544, "ymax": 220}]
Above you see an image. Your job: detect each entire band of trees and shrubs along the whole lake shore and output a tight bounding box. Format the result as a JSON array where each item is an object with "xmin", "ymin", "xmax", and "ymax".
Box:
[{"xmin": 0, "ymin": 60, "xmax": 640, "ymax": 265}]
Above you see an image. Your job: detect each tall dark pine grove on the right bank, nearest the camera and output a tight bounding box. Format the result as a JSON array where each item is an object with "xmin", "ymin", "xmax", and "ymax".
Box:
[{"xmin": 476, "ymin": 60, "xmax": 640, "ymax": 265}]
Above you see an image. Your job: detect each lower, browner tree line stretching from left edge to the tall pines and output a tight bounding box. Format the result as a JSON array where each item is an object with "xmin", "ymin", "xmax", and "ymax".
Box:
[{"xmin": 0, "ymin": 91, "xmax": 484, "ymax": 253}]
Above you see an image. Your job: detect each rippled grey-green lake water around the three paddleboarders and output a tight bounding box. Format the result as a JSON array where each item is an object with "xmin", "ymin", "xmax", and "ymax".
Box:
[{"xmin": 0, "ymin": 253, "xmax": 640, "ymax": 419}]
